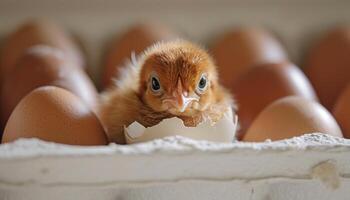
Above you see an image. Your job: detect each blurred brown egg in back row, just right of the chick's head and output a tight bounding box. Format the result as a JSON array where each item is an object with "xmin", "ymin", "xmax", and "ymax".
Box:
[{"xmin": 212, "ymin": 28, "xmax": 287, "ymax": 88}]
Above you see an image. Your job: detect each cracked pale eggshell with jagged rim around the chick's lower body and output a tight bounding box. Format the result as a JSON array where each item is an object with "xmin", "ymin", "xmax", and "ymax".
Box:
[{"xmin": 124, "ymin": 109, "xmax": 237, "ymax": 144}]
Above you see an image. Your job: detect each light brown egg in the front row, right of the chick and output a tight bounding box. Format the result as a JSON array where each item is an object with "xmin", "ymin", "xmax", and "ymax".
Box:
[{"xmin": 243, "ymin": 96, "xmax": 342, "ymax": 142}]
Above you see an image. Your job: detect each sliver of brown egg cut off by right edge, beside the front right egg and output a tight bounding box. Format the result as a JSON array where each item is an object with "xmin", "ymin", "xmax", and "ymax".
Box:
[{"xmin": 333, "ymin": 82, "xmax": 350, "ymax": 138}]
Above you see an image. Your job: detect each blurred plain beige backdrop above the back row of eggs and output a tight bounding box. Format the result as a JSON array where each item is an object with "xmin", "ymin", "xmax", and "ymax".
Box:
[{"xmin": 0, "ymin": 0, "xmax": 350, "ymax": 82}]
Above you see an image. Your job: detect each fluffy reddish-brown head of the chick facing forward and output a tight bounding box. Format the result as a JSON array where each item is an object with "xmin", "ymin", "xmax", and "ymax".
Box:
[{"xmin": 139, "ymin": 40, "xmax": 218, "ymax": 116}]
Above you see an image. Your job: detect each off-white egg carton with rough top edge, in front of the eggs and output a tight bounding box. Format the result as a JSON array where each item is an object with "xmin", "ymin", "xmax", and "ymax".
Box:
[{"xmin": 0, "ymin": 134, "xmax": 350, "ymax": 200}]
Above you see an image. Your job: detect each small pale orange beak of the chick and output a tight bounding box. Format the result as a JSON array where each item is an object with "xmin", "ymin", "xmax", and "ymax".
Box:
[{"xmin": 163, "ymin": 80, "xmax": 198, "ymax": 112}]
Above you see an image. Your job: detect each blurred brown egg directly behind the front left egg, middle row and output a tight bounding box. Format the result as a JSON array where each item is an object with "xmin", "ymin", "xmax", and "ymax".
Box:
[{"xmin": 0, "ymin": 45, "xmax": 98, "ymax": 123}]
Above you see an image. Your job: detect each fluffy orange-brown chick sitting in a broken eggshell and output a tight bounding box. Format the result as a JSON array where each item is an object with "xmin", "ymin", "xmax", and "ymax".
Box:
[{"xmin": 100, "ymin": 40, "xmax": 235, "ymax": 144}]
